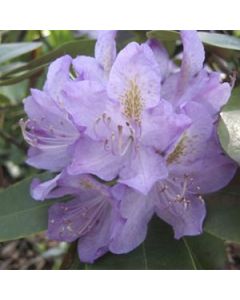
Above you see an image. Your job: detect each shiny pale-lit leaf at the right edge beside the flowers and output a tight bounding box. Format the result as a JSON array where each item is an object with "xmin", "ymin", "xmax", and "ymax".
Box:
[{"xmin": 218, "ymin": 87, "xmax": 240, "ymax": 164}]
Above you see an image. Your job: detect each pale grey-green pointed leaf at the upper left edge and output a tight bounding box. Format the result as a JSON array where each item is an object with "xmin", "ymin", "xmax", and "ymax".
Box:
[{"xmin": 0, "ymin": 42, "xmax": 42, "ymax": 63}]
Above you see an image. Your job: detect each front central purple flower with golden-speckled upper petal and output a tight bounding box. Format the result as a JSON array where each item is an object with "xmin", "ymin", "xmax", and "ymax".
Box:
[{"xmin": 48, "ymin": 34, "xmax": 190, "ymax": 194}]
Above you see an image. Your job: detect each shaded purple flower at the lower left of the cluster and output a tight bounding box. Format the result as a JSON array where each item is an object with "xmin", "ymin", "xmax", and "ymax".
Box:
[{"xmin": 32, "ymin": 172, "xmax": 123, "ymax": 263}]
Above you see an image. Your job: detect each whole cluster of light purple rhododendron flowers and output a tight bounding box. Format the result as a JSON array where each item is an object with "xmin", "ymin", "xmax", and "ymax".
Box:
[{"xmin": 21, "ymin": 31, "xmax": 236, "ymax": 263}]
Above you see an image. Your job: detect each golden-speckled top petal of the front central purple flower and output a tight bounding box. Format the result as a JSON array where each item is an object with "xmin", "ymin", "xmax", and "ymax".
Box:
[{"xmin": 108, "ymin": 42, "xmax": 161, "ymax": 111}]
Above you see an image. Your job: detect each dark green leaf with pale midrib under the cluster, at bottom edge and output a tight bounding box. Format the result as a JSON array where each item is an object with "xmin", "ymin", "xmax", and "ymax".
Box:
[{"xmin": 63, "ymin": 218, "xmax": 196, "ymax": 270}]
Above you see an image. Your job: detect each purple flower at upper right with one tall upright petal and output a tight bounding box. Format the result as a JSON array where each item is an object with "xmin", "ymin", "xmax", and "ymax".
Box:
[{"xmin": 161, "ymin": 31, "xmax": 231, "ymax": 118}]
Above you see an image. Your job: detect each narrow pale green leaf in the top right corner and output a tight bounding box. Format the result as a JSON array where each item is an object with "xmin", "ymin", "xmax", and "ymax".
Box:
[{"xmin": 198, "ymin": 32, "xmax": 240, "ymax": 50}]
